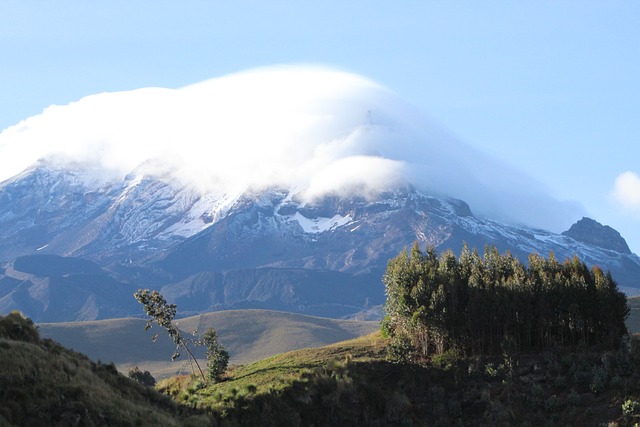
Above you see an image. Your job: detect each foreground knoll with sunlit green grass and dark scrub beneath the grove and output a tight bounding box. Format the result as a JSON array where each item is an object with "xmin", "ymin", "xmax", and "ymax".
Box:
[{"xmin": 158, "ymin": 334, "xmax": 640, "ymax": 427}]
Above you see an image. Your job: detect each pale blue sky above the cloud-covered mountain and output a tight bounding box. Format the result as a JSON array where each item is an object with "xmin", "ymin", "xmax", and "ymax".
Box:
[{"xmin": 0, "ymin": 0, "xmax": 640, "ymax": 253}]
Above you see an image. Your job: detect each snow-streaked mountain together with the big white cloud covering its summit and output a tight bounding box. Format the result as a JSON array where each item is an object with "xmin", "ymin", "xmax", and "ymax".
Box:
[{"xmin": 0, "ymin": 66, "xmax": 640, "ymax": 321}]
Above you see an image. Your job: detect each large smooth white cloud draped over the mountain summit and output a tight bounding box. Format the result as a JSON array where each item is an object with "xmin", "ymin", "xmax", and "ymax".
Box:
[{"xmin": 0, "ymin": 66, "xmax": 580, "ymax": 231}]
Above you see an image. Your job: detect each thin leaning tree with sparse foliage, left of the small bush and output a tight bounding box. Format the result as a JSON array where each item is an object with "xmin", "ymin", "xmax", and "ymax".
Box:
[{"xmin": 133, "ymin": 289, "xmax": 205, "ymax": 380}]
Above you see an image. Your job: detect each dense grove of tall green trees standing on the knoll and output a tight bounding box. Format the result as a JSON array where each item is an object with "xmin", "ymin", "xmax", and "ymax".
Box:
[{"xmin": 382, "ymin": 243, "xmax": 629, "ymax": 358}]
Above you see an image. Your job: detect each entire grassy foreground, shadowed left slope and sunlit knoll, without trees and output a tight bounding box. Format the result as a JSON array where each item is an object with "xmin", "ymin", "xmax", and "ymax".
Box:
[{"xmin": 6, "ymin": 308, "xmax": 640, "ymax": 426}]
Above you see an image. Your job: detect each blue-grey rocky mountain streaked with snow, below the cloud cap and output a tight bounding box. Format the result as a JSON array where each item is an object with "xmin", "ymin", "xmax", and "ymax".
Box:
[{"xmin": 0, "ymin": 161, "xmax": 640, "ymax": 322}]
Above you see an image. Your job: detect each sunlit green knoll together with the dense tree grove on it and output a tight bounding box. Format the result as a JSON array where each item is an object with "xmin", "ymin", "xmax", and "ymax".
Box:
[{"xmin": 159, "ymin": 246, "xmax": 640, "ymax": 426}]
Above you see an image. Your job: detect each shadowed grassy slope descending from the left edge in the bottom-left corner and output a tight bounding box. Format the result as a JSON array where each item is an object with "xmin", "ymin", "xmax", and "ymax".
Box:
[{"xmin": 0, "ymin": 313, "xmax": 213, "ymax": 426}]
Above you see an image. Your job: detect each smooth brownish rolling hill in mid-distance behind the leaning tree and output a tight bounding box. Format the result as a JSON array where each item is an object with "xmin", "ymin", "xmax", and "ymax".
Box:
[{"xmin": 38, "ymin": 310, "xmax": 378, "ymax": 378}]
